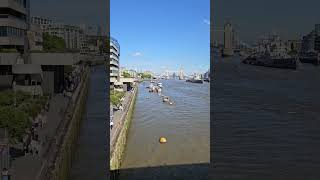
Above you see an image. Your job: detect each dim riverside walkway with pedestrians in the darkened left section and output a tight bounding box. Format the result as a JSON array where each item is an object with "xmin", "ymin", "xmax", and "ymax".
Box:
[{"xmin": 9, "ymin": 66, "xmax": 89, "ymax": 180}]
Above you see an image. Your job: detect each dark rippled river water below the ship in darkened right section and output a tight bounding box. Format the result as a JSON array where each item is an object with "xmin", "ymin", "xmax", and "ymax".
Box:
[{"xmin": 212, "ymin": 57, "xmax": 320, "ymax": 180}]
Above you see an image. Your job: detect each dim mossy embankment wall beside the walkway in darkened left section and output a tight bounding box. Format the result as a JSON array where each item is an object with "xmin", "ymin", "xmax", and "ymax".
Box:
[{"xmin": 36, "ymin": 68, "xmax": 90, "ymax": 180}]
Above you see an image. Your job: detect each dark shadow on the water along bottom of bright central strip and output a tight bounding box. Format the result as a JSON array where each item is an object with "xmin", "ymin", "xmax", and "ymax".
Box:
[{"xmin": 110, "ymin": 163, "xmax": 210, "ymax": 180}]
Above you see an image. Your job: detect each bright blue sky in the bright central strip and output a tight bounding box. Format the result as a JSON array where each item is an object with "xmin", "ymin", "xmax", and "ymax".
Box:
[{"xmin": 110, "ymin": 0, "xmax": 210, "ymax": 73}]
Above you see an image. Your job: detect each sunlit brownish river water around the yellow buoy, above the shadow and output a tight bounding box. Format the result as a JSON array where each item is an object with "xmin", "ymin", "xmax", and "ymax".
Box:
[{"xmin": 121, "ymin": 80, "xmax": 210, "ymax": 174}]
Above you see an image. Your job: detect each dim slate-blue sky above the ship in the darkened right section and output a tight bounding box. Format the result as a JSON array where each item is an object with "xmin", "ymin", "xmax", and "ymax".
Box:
[{"xmin": 213, "ymin": 0, "xmax": 320, "ymax": 43}]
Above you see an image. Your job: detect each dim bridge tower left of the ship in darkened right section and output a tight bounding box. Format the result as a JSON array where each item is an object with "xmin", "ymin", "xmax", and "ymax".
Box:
[{"xmin": 223, "ymin": 22, "xmax": 234, "ymax": 56}]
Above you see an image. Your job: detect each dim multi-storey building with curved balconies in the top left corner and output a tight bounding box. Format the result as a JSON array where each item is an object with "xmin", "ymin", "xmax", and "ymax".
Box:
[{"xmin": 0, "ymin": 0, "xmax": 30, "ymax": 52}]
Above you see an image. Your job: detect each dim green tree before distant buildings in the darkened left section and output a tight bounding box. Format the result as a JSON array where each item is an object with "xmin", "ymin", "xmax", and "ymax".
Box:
[{"xmin": 43, "ymin": 33, "xmax": 66, "ymax": 51}]
